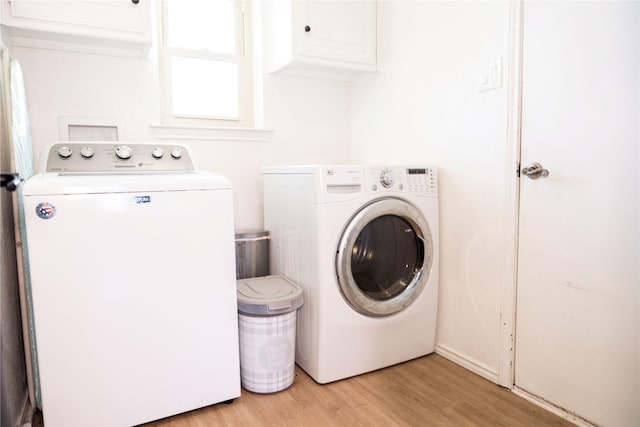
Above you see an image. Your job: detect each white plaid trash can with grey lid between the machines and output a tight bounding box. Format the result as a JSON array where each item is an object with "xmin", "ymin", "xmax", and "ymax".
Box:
[{"xmin": 237, "ymin": 276, "xmax": 303, "ymax": 393}]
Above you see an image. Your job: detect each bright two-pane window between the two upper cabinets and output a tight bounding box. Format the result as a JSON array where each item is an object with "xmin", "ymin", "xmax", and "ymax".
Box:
[{"xmin": 159, "ymin": 0, "xmax": 253, "ymax": 127}]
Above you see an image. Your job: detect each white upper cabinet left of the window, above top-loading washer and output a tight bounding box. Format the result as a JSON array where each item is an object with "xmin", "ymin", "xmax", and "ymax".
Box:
[{"xmin": 1, "ymin": 0, "xmax": 152, "ymax": 57}]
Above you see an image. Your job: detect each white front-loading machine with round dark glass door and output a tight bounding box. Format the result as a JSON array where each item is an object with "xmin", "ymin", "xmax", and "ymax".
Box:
[{"xmin": 262, "ymin": 166, "xmax": 439, "ymax": 383}]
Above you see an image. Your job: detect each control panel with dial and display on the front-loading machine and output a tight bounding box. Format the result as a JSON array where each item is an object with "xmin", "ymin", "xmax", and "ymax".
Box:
[{"xmin": 366, "ymin": 166, "xmax": 438, "ymax": 195}]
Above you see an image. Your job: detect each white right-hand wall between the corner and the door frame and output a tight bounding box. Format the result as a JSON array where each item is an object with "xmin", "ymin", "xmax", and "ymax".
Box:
[{"xmin": 352, "ymin": 0, "xmax": 512, "ymax": 381}]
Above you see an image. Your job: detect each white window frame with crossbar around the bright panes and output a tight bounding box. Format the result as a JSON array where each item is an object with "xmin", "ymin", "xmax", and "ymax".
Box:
[{"xmin": 158, "ymin": 0, "xmax": 254, "ymax": 128}]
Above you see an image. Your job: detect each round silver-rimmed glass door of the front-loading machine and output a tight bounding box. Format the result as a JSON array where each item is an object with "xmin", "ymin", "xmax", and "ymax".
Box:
[{"xmin": 336, "ymin": 198, "xmax": 433, "ymax": 316}]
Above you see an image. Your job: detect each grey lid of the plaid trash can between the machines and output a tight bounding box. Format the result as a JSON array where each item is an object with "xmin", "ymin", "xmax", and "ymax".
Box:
[{"xmin": 236, "ymin": 276, "xmax": 303, "ymax": 315}]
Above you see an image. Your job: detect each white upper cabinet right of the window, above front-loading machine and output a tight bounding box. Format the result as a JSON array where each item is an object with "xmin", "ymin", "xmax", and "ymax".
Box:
[{"xmin": 264, "ymin": 0, "xmax": 377, "ymax": 78}]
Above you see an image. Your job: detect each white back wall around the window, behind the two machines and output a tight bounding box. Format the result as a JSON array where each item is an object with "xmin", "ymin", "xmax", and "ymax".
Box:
[{"xmin": 11, "ymin": 47, "xmax": 351, "ymax": 228}]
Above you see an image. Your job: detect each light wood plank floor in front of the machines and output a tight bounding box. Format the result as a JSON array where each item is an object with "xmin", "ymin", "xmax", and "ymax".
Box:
[{"xmin": 34, "ymin": 354, "xmax": 573, "ymax": 427}]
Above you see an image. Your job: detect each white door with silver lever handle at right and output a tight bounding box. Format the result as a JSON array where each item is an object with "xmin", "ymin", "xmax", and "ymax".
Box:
[{"xmin": 515, "ymin": 1, "xmax": 640, "ymax": 426}]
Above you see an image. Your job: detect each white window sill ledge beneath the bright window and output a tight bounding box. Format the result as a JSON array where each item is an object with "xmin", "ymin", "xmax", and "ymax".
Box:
[{"xmin": 151, "ymin": 125, "xmax": 273, "ymax": 142}]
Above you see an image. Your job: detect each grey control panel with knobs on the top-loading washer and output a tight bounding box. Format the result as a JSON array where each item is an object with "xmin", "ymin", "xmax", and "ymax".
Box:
[{"xmin": 46, "ymin": 141, "xmax": 195, "ymax": 173}]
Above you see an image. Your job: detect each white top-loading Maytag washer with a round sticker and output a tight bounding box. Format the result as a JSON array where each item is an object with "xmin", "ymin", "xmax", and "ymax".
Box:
[{"xmin": 23, "ymin": 142, "xmax": 240, "ymax": 426}]
